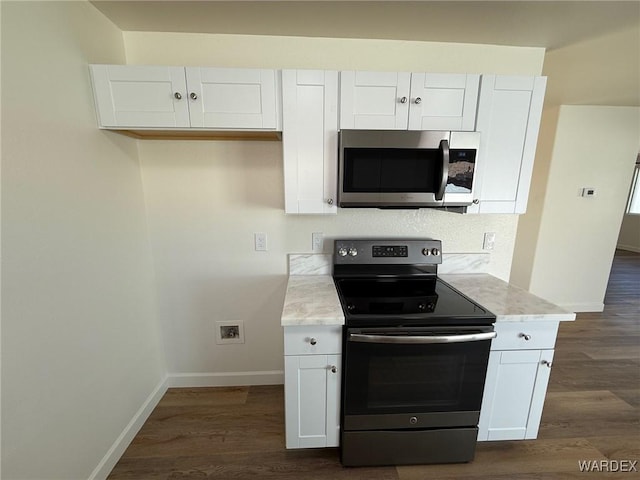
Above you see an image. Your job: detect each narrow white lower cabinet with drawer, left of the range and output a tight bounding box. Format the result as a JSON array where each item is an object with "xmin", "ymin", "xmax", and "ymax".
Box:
[{"xmin": 284, "ymin": 326, "xmax": 342, "ymax": 448}]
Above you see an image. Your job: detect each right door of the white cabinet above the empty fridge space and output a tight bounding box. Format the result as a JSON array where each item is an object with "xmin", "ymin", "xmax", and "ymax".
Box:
[{"xmin": 186, "ymin": 67, "xmax": 279, "ymax": 130}]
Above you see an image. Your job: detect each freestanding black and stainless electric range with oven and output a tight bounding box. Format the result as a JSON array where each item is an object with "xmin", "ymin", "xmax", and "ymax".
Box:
[{"xmin": 333, "ymin": 239, "xmax": 496, "ymax": 466}]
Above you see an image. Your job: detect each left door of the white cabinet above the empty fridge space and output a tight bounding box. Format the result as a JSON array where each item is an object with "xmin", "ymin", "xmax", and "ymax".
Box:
[{"xmin": 90, "ymin": 65, "xmax": 189, "ymax": 128}]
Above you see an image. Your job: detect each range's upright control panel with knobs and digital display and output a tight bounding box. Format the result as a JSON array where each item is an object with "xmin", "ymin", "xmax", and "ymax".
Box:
[{"xmin": 333, "ymin": 239, "xmax": 442, "ymax": 265}]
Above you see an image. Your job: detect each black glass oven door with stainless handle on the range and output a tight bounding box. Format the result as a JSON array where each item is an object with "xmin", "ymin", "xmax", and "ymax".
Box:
[{"xmin": 342, "ymin": 326, "xmax": 496, "ymax": 431}]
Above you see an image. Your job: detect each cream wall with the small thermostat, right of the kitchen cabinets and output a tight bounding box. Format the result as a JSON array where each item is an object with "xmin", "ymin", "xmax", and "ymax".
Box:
[{"xmin": 512, "ymin": 105, "xmax": 640, "ymax": 311}]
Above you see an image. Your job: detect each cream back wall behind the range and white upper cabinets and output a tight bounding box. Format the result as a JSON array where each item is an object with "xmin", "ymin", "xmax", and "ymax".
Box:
[{"xmin": 125, "ymin": 32, "xmax": 544, "ymax": 378}]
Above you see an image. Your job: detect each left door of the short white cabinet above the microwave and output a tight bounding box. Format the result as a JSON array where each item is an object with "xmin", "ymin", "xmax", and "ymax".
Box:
[{"xmin": 340, "ymin": 71, "xmax": 411, "ymax": 130}]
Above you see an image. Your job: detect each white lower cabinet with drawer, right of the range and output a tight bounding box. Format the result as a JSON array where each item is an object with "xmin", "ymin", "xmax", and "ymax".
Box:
[{"xmin": 478, "ymin": 322, "xmax": 558, "ymax": 441}]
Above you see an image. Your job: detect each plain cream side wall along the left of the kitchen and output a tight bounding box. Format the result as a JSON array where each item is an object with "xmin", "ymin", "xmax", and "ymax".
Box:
[{"xmin": 1, "ymin": 1, "xmax": 164, "ymax": 480}]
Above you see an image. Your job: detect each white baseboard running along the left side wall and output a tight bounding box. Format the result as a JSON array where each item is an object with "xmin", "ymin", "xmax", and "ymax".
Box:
[{"xmin": 89, "ymin": 376, "xmax": 168, "ymax": 480}]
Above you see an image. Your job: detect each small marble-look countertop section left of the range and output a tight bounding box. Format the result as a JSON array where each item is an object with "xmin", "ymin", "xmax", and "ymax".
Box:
[{"xmin": 281, "ymin": 275, "xmax": 344, "ymax": 327}]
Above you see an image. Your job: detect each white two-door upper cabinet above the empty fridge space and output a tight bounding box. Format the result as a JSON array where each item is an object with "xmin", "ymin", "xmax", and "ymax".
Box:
[{"xmin": 91, "ymin": 65, "xmax": 280, "ymax": 130}]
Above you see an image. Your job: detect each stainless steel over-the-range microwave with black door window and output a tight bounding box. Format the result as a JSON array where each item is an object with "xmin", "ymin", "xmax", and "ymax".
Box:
[{"xmin": 338, "ymin": 130, "xmax": 480, "ymax": 208}]
